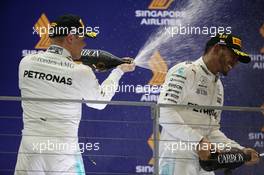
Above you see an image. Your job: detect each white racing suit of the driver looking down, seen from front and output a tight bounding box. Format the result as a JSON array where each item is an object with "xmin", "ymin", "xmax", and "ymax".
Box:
[{"xmin": 158, "ymin": 58, "xmax": 243, "ymax": 175}]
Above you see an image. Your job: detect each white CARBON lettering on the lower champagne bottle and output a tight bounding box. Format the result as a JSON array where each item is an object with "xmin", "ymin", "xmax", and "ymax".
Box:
[{"xmin": 217, "ymin": 153, "xmax": 244, "ymax": 164}]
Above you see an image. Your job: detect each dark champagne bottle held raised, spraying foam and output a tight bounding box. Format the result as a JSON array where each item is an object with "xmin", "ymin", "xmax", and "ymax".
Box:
[{"xmin": 81, "ymin": 49, "xmax": 132, "ymax": 72}]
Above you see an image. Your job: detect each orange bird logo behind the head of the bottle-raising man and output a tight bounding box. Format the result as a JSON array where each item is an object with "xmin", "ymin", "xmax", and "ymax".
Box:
[{"xmin": 34, "ymin": 13, "xmax": 50, "ymax": 49}]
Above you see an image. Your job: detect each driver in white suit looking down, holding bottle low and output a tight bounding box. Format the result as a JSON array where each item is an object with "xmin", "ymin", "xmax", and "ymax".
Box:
[{"xmin": 158, "ymin": 34, "xmax": 259, "ymax": 175}]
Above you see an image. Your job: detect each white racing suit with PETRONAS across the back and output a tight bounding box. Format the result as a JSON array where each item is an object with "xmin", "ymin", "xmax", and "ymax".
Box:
[{"xmin": 15, "ymin": 45, "xmax": 123, "ymax": 175}]
